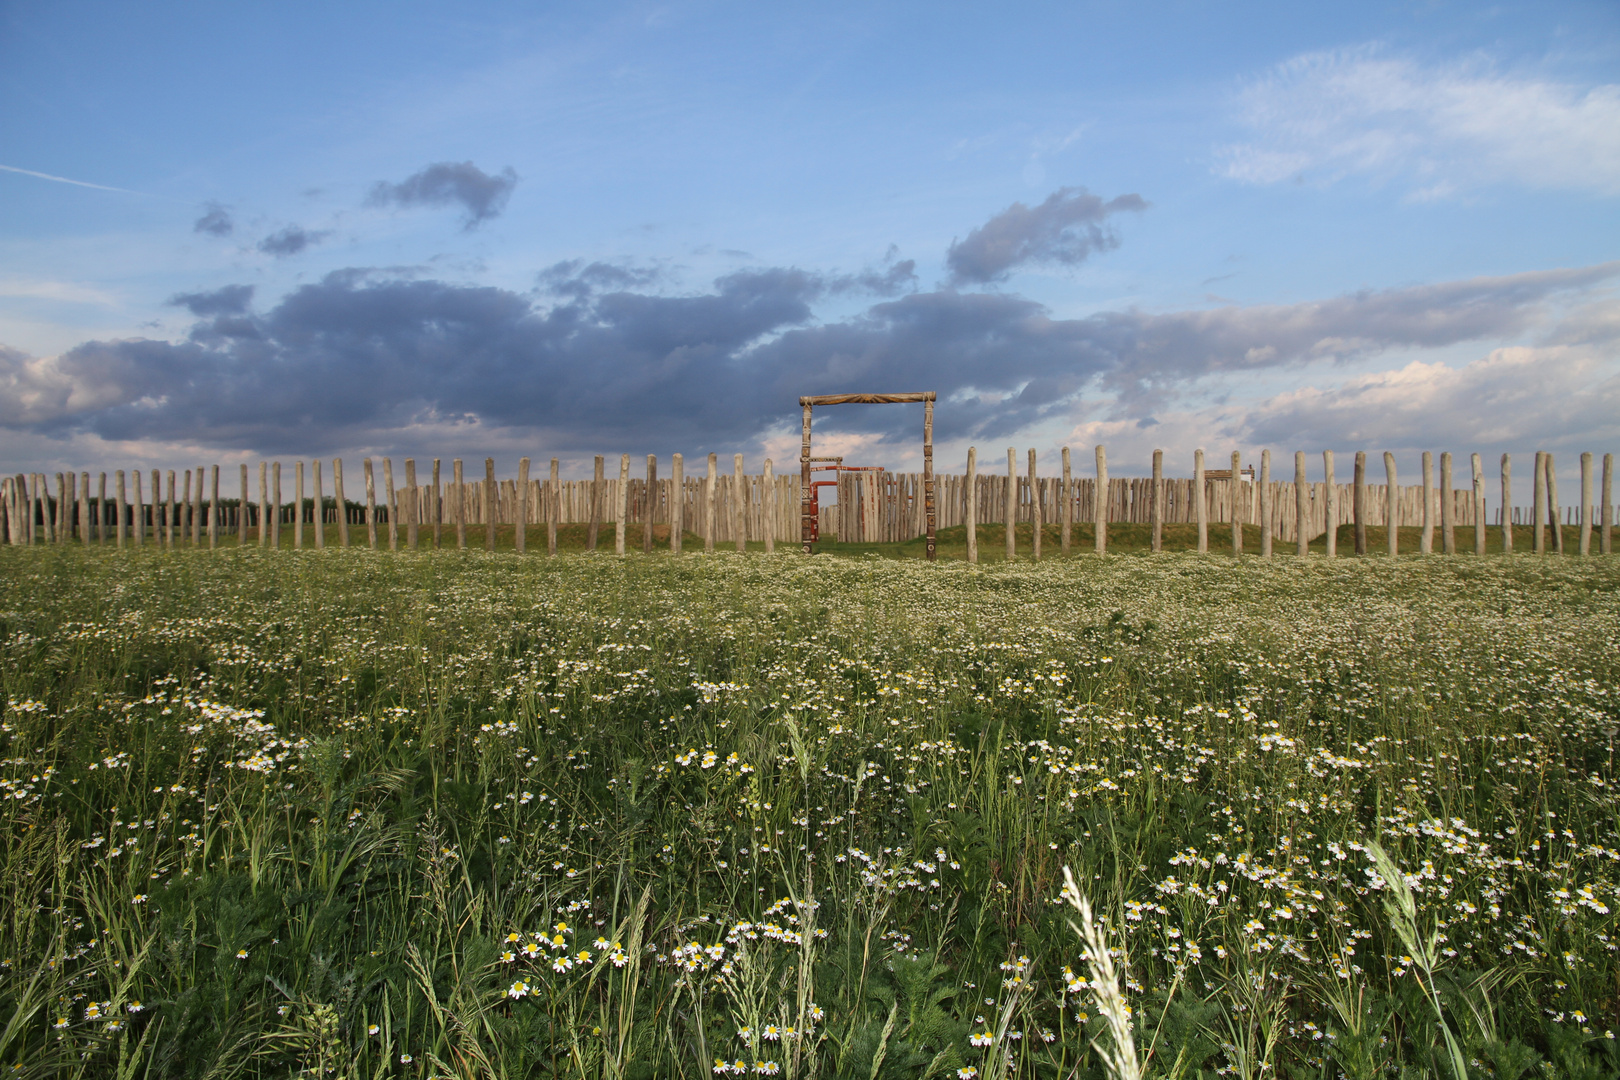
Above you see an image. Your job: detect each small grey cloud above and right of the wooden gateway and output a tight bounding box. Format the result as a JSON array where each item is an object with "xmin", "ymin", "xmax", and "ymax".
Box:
[{"xmin": 944, "ymin": 188, "xmax": 1147, "ymax": 285}]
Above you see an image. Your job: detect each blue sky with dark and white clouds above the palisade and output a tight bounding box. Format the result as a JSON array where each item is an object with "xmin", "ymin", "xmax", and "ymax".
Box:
[{"xmin": 0, "ymin": 0, "xmax": 1620, "ymax": 498}]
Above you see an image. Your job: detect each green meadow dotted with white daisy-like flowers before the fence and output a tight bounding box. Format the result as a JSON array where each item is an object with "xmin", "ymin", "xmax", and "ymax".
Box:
[{"xmin": 0, "ymin": 547, "xmax": 1620, "ymax": 1080}]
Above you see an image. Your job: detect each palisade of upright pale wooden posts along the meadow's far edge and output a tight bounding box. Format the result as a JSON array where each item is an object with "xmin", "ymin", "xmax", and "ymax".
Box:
[{"xmin": 0, "ymin": 447, "xmax": 1615, "ymax": 559}]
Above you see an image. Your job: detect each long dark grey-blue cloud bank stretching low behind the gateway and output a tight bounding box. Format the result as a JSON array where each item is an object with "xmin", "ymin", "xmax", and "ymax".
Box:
[{"xmin": 0, "ymin": 264, "xmax": 1620, "ymax": 453}]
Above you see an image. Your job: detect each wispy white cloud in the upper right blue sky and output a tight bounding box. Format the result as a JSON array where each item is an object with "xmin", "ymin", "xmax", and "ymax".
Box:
[{"xmin": 1217, "ymin": 47, "xmax": 1620, "ymax": 198}]
